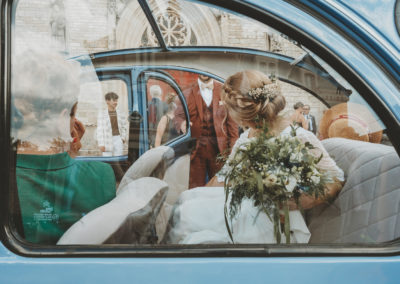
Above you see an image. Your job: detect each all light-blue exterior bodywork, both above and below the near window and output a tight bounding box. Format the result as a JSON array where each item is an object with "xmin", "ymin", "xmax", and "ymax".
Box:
[{"xmin": 0, "ymin": 0, "xmax": 400, "ymax": 284}]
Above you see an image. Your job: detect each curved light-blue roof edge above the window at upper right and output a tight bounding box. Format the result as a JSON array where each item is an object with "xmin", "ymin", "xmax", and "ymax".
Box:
[{"xmin": 246, "ymin": 0, "xmax": 400, "ymax": 121}]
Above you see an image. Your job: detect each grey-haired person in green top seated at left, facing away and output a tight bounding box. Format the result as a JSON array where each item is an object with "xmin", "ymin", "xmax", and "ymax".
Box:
[{"xmin": 11, "ymin": 48, "xmax": 116, "ymax": 245}]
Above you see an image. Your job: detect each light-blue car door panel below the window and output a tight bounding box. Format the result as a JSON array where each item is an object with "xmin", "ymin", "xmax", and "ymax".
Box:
[{"xmin": 0, "ymin": 242, "xmax": 399, "ymax": 284}]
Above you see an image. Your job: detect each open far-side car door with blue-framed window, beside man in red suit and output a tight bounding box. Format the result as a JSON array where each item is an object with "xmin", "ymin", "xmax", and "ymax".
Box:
[{"xmin": 137, "ymin": 69, "xmax": 192, "ymax": 189}]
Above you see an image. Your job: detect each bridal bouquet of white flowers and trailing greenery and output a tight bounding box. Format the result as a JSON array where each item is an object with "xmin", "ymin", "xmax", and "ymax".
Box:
[{"xmin": 224, "ymin": 128, "xmax": 329, "ymax": 243}]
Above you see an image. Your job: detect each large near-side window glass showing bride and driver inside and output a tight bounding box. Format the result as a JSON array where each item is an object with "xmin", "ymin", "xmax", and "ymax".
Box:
[{"xmin": 7, "ymin": 0, "xmax": 400, "ymax": 249}]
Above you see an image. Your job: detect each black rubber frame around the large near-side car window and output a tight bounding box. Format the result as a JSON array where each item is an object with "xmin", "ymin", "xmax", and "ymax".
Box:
[{"xmin": 0, "ymin": 0, "xmax": 400, "ymax": 257}]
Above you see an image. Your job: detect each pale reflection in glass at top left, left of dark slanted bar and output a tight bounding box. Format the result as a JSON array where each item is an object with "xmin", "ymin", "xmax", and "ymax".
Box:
[{"xmin": 13, "ymin": 0, "xmax": 158, "ymax": 56}]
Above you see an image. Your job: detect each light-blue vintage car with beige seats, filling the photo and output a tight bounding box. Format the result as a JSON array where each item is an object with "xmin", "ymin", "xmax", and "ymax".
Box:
[{"xmin": 0, "ymin": 0, "xmax": 400, "ymax": 283}]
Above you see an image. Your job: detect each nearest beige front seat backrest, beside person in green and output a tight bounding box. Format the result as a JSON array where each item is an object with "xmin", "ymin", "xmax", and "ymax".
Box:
[{"xmin": 57, "ymin": 177, "xmax": 168, "ymax": 245}]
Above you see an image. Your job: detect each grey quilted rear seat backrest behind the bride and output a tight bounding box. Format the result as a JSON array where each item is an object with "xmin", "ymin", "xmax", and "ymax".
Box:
[{"xmin": 307, "ymin": 138, "xmax": 400, "ymax": 243}]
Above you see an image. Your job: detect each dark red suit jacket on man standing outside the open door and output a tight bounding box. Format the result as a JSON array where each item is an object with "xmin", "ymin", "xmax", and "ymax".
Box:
[{"xmin": 175, "ymin": 82, "xmax": 239, "ymax": 158}]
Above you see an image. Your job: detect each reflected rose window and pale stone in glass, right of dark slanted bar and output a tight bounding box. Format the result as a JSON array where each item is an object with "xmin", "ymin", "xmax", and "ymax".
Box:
[{"xmin": 149, "ymin": 0, "xmax": 303, "ymax": 57}]
